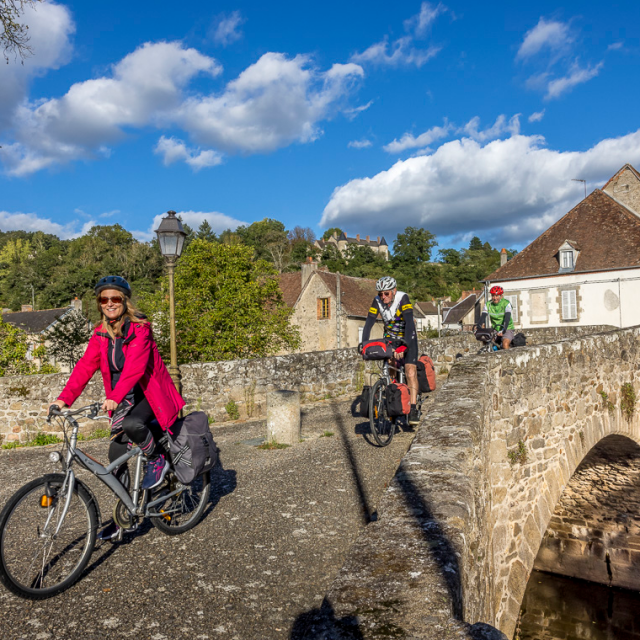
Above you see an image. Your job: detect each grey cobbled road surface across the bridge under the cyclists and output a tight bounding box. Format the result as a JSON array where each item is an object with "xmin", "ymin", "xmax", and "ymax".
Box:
[{"xmin": 0, "ymin": 403, "xmax": 430, "ymax": 640}]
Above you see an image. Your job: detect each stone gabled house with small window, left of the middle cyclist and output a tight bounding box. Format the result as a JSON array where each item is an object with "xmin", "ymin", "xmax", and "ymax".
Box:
[{"xmin": 280, "ymin": 262, "xmax": 382, "ymax": 352}]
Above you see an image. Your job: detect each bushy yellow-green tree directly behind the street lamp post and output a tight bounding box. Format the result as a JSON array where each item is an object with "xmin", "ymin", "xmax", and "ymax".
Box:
[{"xmin": 143, "ymin": 238, "xmax": 300, "ymax": 363}]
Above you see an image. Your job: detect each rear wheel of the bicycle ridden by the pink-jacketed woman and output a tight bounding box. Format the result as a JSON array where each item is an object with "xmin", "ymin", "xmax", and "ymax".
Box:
[{"xmin": 151, "ymin": 471, "xmax": 211, "ymax": 536}]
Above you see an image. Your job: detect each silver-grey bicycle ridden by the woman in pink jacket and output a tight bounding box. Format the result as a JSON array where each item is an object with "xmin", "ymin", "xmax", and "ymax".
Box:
[{"xmin": 0, "ymin": 402, "xmax": 211, "ymax": 600}]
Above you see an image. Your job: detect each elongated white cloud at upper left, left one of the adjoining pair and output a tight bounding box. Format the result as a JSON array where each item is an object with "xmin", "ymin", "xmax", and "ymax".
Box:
[{"xmin": 4, "ymin": 42, "xmax": 221, "ymax": 176}]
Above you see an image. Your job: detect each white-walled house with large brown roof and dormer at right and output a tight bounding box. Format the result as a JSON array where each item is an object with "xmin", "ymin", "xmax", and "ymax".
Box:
[{"xmin": 484, "ymin": 164, "xmax": 640, "ymax": 329}]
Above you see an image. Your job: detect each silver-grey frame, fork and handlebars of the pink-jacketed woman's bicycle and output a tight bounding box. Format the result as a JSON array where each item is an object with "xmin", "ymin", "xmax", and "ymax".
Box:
[{"xmin": 53, "ymin": 405, "xmax": 184, "ymax": 533}]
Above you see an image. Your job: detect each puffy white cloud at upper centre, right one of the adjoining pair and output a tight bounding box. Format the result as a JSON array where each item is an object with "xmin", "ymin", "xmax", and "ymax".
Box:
[{"xmin": 176, "ymin": 53, "xmax": 364, "ymax": 153}]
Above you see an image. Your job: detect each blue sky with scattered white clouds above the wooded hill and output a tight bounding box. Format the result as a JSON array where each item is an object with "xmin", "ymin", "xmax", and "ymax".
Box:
[{"xmin": 0, "ymin": 1, "xmax": 640, "ymax": 248}]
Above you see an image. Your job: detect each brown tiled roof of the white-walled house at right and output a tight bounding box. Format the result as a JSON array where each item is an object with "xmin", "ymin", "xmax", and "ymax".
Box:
[{"xmin": 485, "ymin": 189, "xmax": 640, "ymax": 282}]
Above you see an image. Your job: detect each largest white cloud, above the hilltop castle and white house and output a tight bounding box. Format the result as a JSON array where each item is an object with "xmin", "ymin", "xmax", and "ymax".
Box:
[{"xmin": 320, "ymin": 130, "xmax": 640, "ymax": 246}]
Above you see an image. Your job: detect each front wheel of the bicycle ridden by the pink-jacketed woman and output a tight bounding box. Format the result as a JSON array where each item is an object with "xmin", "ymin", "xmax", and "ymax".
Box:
[{"xmin": 0, "ymin": 474, "xmax": 98, "ymax": 600}]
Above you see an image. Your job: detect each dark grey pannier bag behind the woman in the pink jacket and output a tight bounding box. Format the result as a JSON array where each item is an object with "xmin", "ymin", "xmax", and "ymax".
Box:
[{"xmin": 163, "ymin": 411, "xmax": 218, "ymax": 484}]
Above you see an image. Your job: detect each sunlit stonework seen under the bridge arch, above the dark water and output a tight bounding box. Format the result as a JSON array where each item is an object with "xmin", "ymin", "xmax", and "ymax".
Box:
[{"xmin": 534, "ymin": 435, "xmax": 640, "ymax": 592}]
